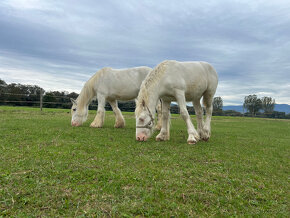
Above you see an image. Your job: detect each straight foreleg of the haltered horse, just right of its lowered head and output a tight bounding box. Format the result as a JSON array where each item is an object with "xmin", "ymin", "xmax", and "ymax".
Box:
[{"xmin": 156, "ymin": 101, "xmax": 171, "ymax": 141}]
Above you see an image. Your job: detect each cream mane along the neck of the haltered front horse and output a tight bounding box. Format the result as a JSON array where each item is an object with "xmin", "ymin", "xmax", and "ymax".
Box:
[{"xmin": 135, "ymin": 61, "xmax": 169, "ymax": 116}]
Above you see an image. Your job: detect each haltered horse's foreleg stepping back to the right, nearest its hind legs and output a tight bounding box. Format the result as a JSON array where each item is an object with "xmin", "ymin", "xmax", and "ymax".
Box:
[{"xmin": 175, "ymin": 91, "xmax": 199, "ymax": 144}]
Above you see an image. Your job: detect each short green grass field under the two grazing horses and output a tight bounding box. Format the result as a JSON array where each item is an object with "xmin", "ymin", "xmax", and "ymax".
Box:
[{"xmin": 0, "ymin": 107, "xmax": 290, "ymax": 217}]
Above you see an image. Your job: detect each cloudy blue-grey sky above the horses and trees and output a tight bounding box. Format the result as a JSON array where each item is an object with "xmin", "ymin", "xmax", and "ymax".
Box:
[{"xmin": 0, "ymin": 0, "xmax": 290, "ymax": 105}]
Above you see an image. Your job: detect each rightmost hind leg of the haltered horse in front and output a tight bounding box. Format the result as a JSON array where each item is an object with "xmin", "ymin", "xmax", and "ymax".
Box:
[{"xmin": 202, "ymin": 92, "xmax": 214, "ymax": 141}]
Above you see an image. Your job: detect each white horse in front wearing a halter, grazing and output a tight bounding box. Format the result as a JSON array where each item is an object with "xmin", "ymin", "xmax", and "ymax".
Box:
[{"xmin": 135, "ymin": 61, "xmax": 218, "ymax": 144}]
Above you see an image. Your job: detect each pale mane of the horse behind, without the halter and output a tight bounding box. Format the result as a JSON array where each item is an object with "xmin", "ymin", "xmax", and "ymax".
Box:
[{"xmin": 77, "ymin": 67, "xmax": 111, "ymax": 110}]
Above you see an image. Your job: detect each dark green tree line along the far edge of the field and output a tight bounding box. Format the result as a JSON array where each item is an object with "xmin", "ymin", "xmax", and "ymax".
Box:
[{"xmin": 0, "ymin": 79, "xmax": 290, "ymax": 119}]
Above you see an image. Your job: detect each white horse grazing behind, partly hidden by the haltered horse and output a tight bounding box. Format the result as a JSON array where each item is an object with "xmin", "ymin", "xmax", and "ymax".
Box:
[{"xmin": 71, "ymin": 67, "xmax": 161, "ymax": 129}]
